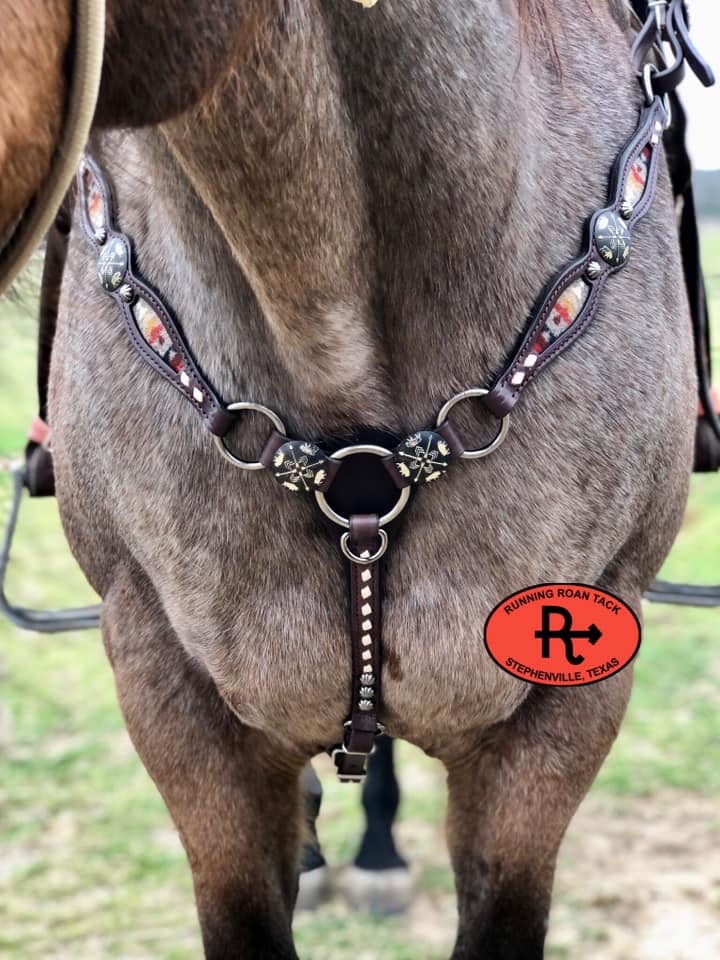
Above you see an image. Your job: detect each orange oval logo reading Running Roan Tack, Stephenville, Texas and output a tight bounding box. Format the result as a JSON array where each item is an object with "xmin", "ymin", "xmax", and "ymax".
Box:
[{"xmin": 485, "ymin": 583, "xmax": 640, "ymax": 687}]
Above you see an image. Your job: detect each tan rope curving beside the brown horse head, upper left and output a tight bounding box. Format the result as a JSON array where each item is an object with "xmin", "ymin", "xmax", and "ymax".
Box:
[{"xmin": 0, "ymin": 0, "xmax": 105, "ymax": 294}]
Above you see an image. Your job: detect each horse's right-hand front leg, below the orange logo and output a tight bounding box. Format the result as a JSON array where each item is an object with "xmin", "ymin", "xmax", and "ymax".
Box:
[{"xmin": 443, "ymin": 671, "xmax": 631, "ymax": 960}]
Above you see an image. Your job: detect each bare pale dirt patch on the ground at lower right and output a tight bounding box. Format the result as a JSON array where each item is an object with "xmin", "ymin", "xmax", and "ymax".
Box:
[{"xmin": 388, "ymin": 792, "xmax": 720, "ymax": 960}]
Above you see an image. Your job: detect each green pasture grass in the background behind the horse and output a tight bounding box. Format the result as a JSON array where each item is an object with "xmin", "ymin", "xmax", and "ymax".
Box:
[{"xmin": 0, "ymin": 233, "xmax": 720, "ymax": 960}]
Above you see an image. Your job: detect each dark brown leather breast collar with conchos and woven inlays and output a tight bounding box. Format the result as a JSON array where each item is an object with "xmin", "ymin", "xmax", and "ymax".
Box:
[{"xmin": 70, "ymin": 0, "xmax": 712, "ymax": 781}]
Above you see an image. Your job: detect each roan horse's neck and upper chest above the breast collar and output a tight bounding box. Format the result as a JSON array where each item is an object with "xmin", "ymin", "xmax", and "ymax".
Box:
[{"xmin": 102, "ymin": 0, "xmax": 634, "ymax": 431}]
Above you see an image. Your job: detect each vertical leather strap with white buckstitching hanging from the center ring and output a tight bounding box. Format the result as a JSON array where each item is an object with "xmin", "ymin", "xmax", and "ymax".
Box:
[{"xmin": 332, "ymin": 514, "xmax": 382, "ymax": 782}]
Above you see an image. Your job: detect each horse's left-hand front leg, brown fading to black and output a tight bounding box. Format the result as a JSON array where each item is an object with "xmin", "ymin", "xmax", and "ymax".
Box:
[{"xmin": 103, "ymin": 580, "xmax": 303, "ymax": 960}]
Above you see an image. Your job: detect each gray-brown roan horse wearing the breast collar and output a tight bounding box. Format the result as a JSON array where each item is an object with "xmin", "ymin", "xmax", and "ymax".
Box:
[{"xmin": 2, "ymin": 0, "xmax": 695, "ymax": 960}]
